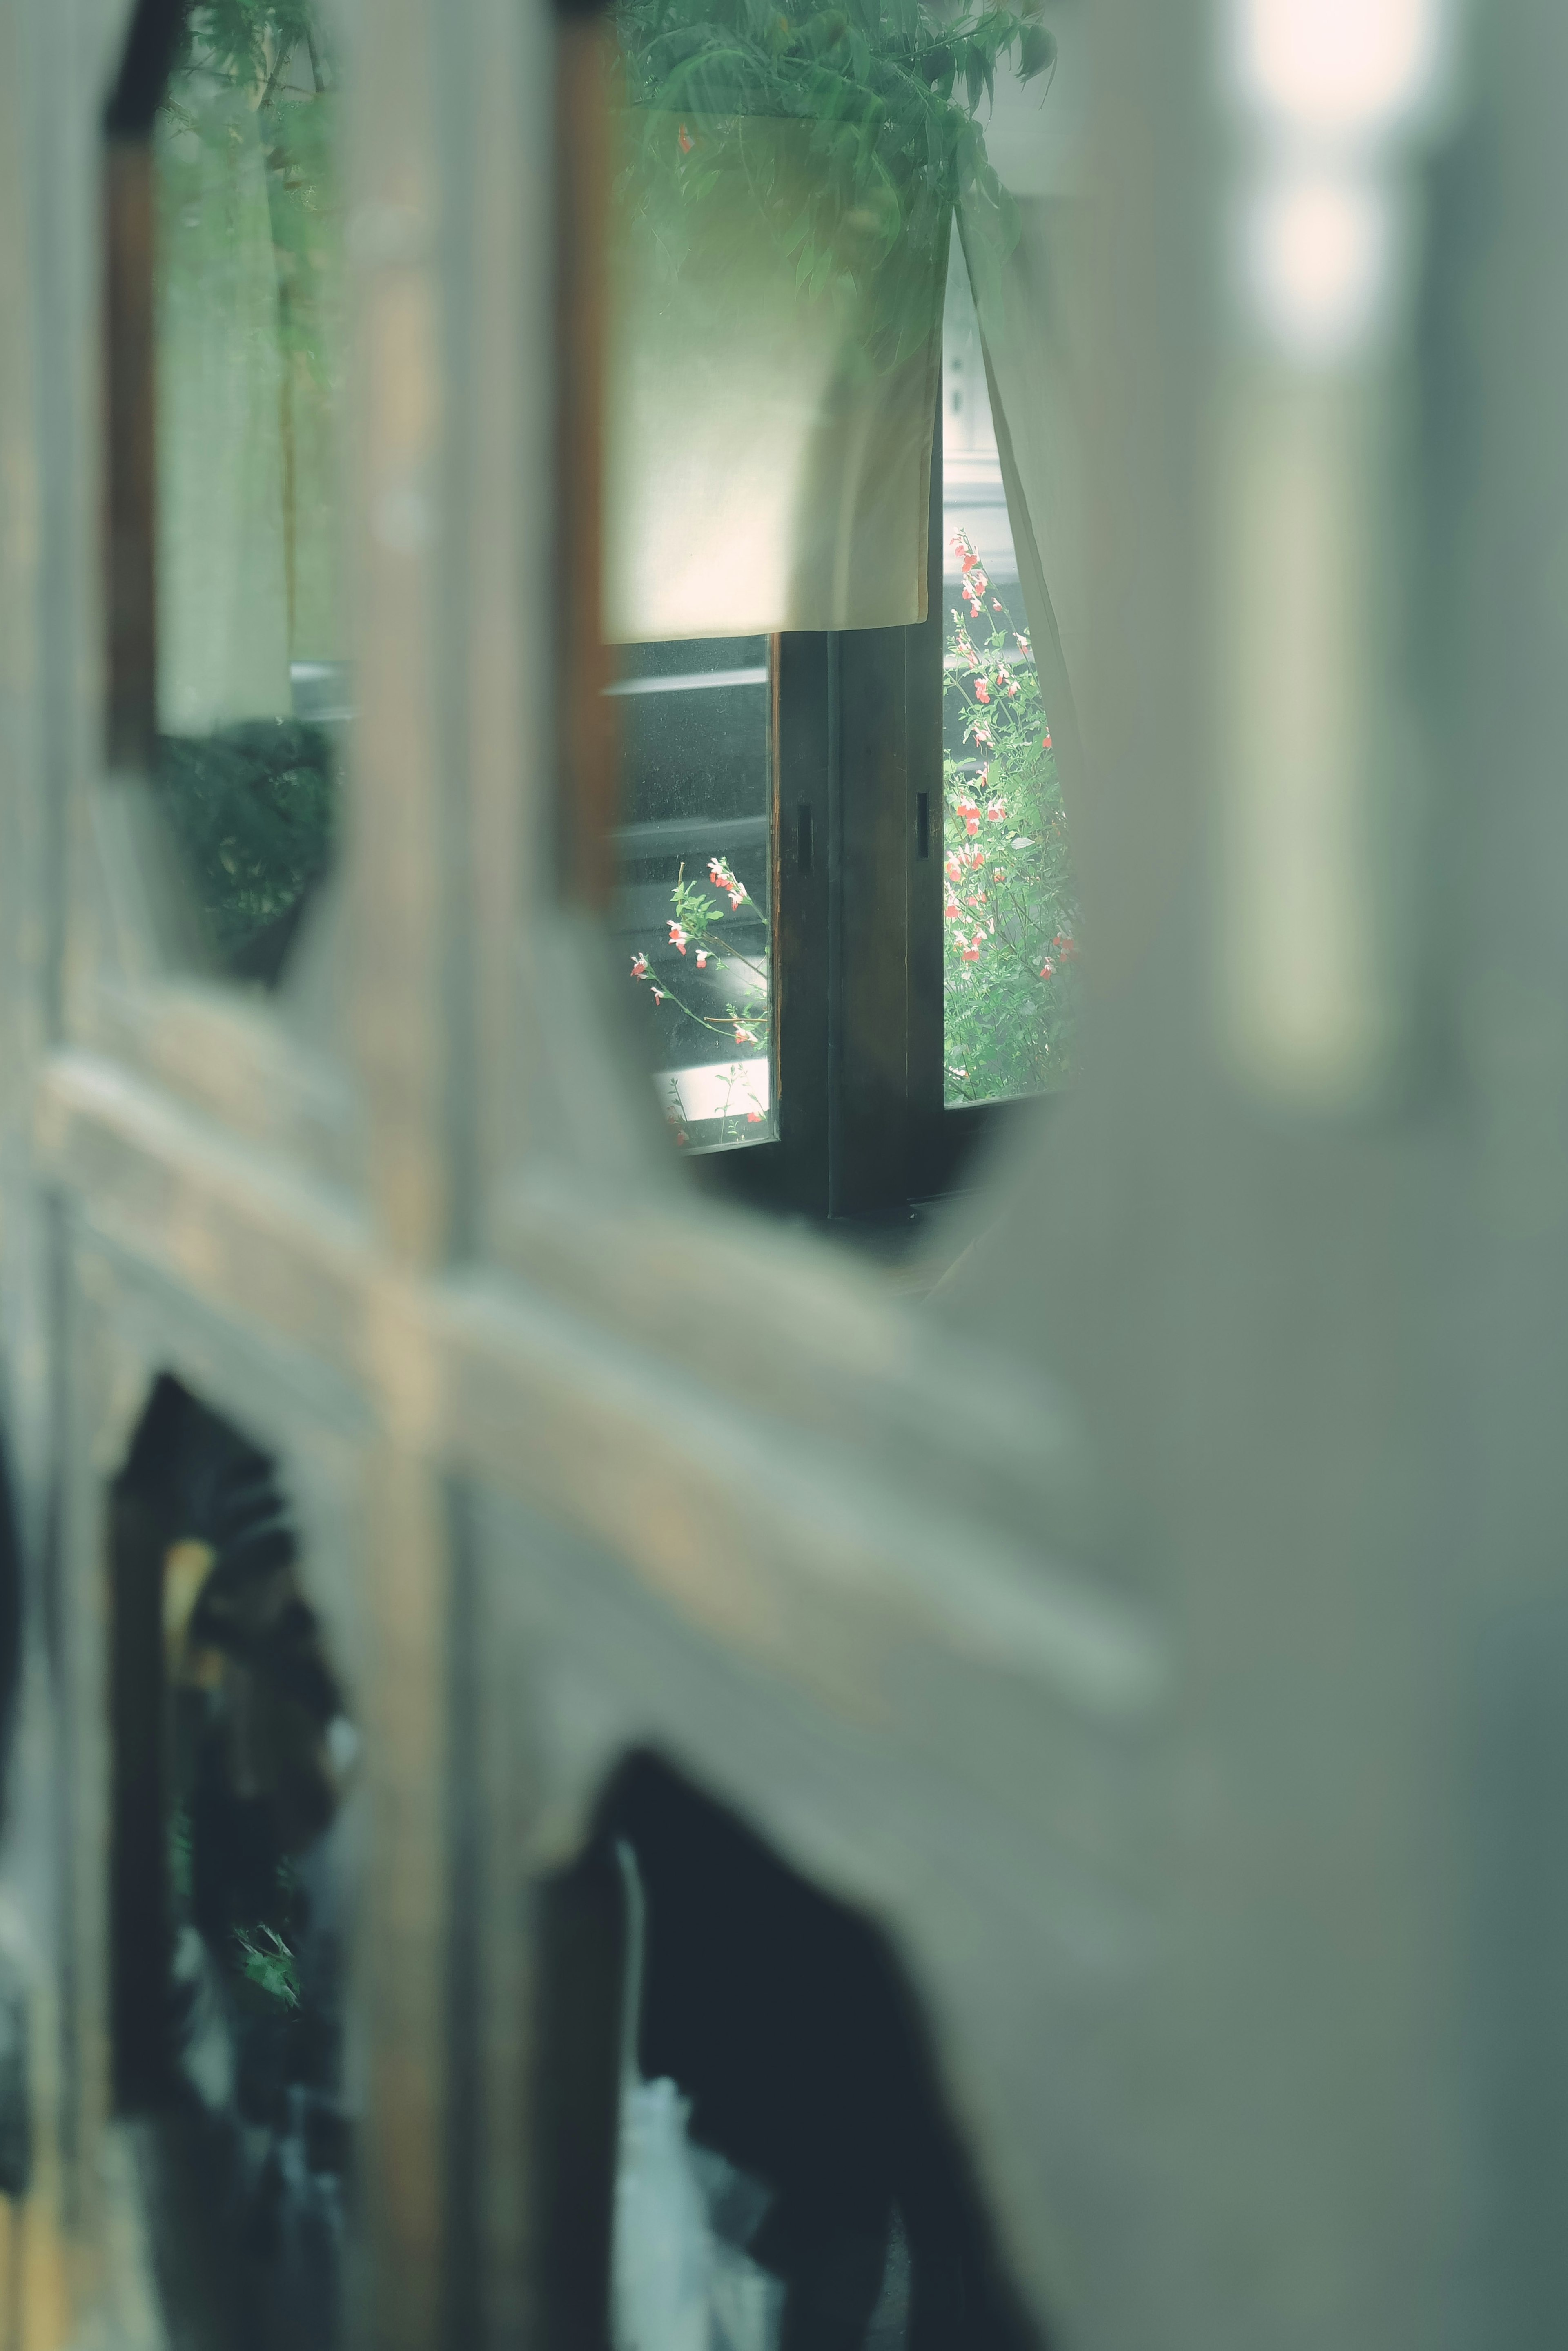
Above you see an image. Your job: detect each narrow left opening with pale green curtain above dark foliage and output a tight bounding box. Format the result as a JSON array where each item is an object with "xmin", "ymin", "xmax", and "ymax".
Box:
[{"xmin": 153, "ymin": 0, "xmax": 348, "ymax": 983}]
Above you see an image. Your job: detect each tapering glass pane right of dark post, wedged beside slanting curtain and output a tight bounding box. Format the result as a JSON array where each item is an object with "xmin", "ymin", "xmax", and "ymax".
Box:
[{"xmin": 943, "ymin": 237, "xmax": 1079, "ymax": 1105}]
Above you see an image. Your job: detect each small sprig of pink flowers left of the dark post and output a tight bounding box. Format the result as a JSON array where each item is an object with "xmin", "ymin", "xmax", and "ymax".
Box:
[{"xmin": 630, "ymin": 858, "xmax": 771, "ymax": 1142}]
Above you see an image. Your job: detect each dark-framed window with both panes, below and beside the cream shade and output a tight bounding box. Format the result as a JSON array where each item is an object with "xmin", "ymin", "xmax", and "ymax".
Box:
[{"xmin": 609, "ymin": 240, "xmax": 1077, "ymax": 1225}]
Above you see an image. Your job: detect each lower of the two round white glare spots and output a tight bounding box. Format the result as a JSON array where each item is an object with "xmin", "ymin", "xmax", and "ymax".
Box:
[{"xmin": 1246, "ymin": 169, "xmax": 1392, "ymax": 364}]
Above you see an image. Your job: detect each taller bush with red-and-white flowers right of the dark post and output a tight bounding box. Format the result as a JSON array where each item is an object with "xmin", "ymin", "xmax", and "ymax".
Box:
[{"xmin": 943, "ymin": 531, "xmax": 1079, "ymax": 1103}]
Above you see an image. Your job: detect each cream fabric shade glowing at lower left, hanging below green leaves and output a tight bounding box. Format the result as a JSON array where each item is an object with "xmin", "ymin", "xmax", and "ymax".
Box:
[{"xmin": 604, "ymin": 108, "xmax": 950, "ymax": 644}]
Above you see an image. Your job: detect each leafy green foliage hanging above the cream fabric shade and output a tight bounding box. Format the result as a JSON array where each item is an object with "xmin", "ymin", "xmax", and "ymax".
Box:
[{"xmin": 616, "ymin": 0, "xmax": 1056, "ymax": 367}]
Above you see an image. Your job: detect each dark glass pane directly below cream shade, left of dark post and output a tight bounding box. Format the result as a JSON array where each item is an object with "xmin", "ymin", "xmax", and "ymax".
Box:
[{"xmin": 609, "ymin": 637, "xmax": 778, "ymax": 1150}]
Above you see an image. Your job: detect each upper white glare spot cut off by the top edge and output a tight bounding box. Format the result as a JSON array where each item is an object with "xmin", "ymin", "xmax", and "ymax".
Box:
[{"xmin": 1236, "ymin": 0, "xmax": 1441, "ymax": 136}]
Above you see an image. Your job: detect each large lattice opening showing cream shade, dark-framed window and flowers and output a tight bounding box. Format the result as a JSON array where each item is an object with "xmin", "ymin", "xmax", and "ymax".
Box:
[{"xmin": 588, "ymin": 13, "xmax": 1079, "ymax": 1225}]
